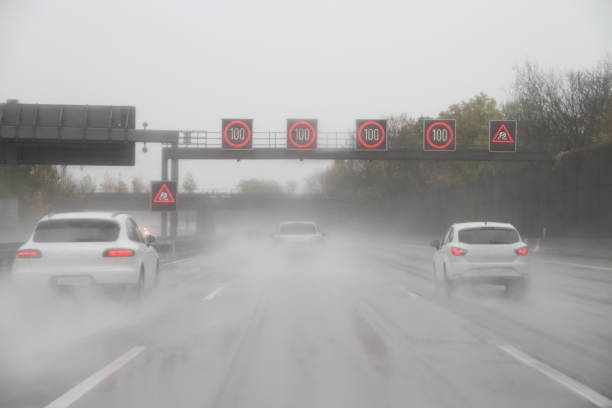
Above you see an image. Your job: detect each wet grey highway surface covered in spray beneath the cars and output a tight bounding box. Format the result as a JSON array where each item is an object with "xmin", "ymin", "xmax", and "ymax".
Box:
[{"xmin": 0, "ymin": 237, "xmax": 612, "ymax": 408}]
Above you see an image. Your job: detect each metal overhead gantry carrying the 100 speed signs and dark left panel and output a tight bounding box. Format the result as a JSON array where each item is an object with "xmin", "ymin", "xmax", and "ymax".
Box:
[{"xmin": 0, "ymin": 100, "xmax": 554, "ymax": 237}]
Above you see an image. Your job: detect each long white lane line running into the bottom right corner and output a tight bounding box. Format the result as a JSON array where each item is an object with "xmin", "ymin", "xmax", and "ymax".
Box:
[{"xmin": 497, "ymin": 344, "xmax": 612, "ymax": 407}]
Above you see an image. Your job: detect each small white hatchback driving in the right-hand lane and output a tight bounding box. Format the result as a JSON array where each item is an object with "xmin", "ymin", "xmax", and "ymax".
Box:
[{"xmin": 431, "ymin": 222, "xmax": 529, "ymax": 293}]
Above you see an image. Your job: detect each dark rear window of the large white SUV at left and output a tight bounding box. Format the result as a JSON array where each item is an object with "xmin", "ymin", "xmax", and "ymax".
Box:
[{"xmin": 34, "ymin": 219, "xmax": 119, "ymax": 242}]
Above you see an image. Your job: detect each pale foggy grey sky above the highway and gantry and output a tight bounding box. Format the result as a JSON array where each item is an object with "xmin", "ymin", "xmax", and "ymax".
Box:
[{"xmin": 0, "ymin": 0, "xmax": 612, "ymax": 189}]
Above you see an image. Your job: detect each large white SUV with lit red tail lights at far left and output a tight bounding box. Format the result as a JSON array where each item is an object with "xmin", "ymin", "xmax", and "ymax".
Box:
[{"xmin": 12, "ymin": 212, "xmax": 159, "ymax": 294}]
